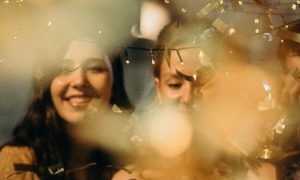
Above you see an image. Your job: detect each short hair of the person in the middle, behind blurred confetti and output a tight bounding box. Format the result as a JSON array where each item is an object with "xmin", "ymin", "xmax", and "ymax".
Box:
[{"xmin": 153, "ymin": 19, "xmax": 248, "ymax": 78}]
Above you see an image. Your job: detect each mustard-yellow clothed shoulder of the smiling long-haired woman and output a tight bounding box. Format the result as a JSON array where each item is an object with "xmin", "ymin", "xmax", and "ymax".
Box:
[{"xmin": 0, "ymin": 146, "xmax": 38, "ymax": 180}]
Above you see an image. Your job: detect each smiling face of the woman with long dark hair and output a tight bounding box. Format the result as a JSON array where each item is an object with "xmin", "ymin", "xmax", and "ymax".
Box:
[{"xmin": 50, "ymin": 40, "xmax": 112, "ymax": 122}]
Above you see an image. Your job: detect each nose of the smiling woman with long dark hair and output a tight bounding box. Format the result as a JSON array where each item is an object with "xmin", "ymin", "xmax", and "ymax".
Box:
[{"xmin": 69, "ymin": 68, "xmax": 88, "ymax": 88}]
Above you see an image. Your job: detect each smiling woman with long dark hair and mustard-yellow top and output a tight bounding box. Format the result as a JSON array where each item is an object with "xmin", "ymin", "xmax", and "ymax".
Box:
[{"xmin": 0, "ymin": 33, "xmax": 130, "ymax": 179}]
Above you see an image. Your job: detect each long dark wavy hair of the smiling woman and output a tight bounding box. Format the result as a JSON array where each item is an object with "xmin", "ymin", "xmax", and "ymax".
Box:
[{"xmin": 5, "ymin": 34, "xmax": 131, "ymax": 179}]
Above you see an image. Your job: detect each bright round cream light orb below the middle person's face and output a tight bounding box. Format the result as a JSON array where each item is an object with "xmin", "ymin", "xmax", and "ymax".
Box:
[{"xmin": 149, "ymin": 109, "xmax": 192, "ymax": 157}]
